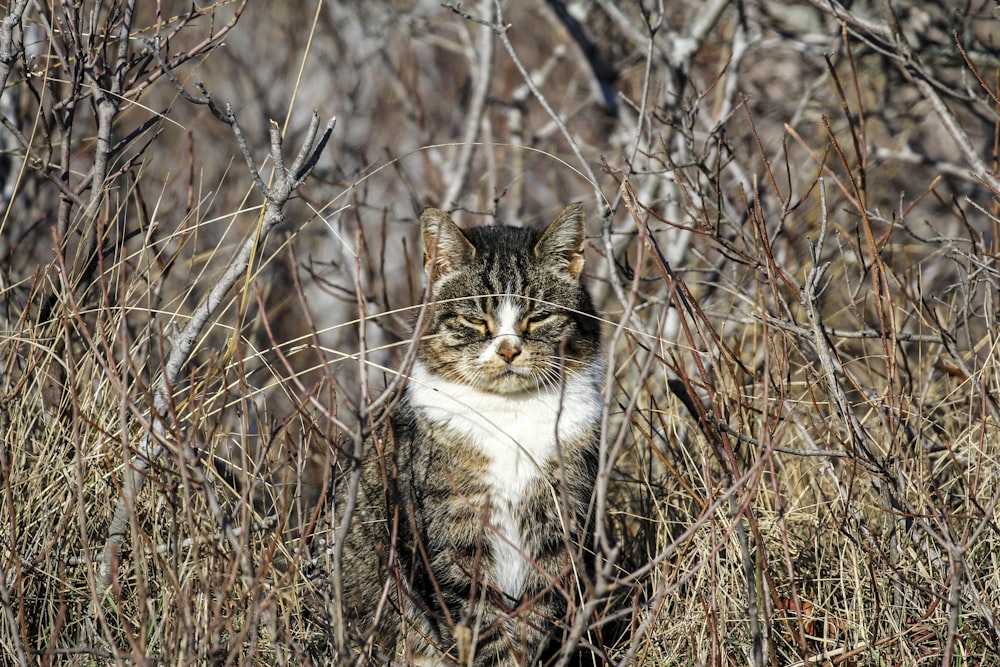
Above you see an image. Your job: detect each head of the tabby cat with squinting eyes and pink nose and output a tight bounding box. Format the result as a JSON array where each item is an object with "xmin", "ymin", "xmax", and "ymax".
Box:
[{"xmin": 419, "ymin": 204, "xmax": 599, "ymax": 394}]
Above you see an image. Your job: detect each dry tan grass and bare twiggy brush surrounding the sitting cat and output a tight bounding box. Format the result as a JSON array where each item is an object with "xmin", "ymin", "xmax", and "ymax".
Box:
[{"xmin": 0, "ymin": 0, "xmax": 1000, "ymax": 665}]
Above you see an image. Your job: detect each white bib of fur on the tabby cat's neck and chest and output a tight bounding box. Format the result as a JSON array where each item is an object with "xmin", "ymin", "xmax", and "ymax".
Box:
[{"xmin": 407, "ymin": 363, "xmax": 601, "ymax": 599}]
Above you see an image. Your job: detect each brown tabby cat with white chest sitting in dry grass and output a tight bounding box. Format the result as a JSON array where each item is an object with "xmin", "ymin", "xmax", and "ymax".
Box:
[{"xmin": 337, "ymin": 204, "xmax": 603, "ymax": 667}]
